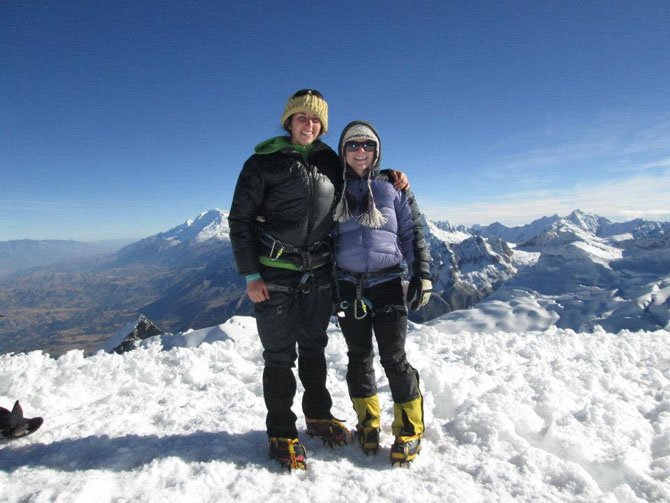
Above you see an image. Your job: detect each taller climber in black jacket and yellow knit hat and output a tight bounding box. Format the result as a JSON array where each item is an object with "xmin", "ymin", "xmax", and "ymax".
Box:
[{"xmin": 229, "ymin": 89, "xmax": 407, "ymax": 469}]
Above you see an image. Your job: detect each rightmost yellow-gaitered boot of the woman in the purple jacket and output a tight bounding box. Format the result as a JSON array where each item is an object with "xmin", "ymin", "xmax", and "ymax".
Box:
[{"xmin": 391, "ymin": 396, "xmax": 424, "ymax": 466}]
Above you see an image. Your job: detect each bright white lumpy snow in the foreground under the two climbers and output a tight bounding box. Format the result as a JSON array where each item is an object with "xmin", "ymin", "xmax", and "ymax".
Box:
[{"xmin": 0, "ymin": 316, "xmax": 670, "ymax": 503}]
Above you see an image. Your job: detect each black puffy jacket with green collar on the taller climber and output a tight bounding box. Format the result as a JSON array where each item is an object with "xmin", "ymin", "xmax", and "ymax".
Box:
[{"xmin": 228, "ymin": 140, "xmax": 343, "ymax": 275}]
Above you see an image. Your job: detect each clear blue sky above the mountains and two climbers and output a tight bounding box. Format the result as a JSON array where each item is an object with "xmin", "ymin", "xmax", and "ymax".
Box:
[{"xmin": 0, "ymin": 0, "xmax": 670, "ymax": 241}]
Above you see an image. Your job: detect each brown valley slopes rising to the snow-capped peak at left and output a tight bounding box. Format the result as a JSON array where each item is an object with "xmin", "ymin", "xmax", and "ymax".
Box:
[{"xmin": 0, "ymin": 211, "xmax": 251, "ymax": 355}]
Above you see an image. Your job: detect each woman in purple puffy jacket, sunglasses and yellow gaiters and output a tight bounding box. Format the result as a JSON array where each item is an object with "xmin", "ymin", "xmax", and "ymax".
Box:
[{"xmin": 334, "ymin": 121, "xmax": 432, "ymax": 464}]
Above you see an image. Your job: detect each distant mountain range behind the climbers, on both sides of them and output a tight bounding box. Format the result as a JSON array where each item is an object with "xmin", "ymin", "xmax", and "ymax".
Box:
[{"xmin": 0, "ymin": 210, "xmax": 670, "ymax": 355}]
